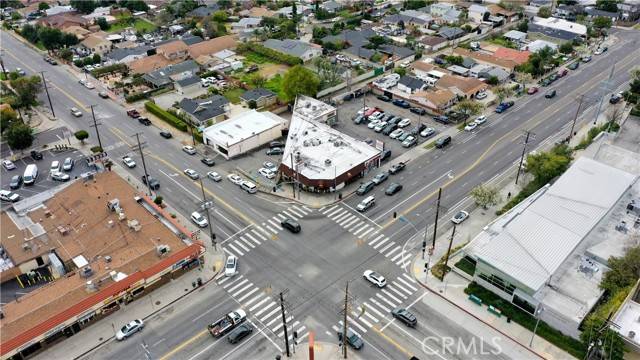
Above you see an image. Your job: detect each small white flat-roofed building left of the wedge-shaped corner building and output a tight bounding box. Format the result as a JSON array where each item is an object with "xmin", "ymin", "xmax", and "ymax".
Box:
[{"xmin": 203, "ymin": 110, "xmax": 286, "ymax": 160}]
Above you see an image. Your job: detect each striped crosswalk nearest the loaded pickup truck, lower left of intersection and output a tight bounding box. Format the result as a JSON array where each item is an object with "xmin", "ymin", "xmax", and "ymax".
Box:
[{"xmin": 217, "ymin": 275, "xmax": 309, "ymax": 341}]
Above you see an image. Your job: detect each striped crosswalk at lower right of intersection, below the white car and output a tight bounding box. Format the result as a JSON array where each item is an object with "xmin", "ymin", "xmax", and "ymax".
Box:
[{"xmin": 331, "ymin": 273, "xmax": 418, "ymax": 337}]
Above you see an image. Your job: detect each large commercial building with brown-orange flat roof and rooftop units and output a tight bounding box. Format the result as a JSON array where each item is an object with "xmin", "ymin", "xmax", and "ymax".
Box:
[{"xmin": 0, "ymin": 172, "xmax": 204, "ymax": 359}]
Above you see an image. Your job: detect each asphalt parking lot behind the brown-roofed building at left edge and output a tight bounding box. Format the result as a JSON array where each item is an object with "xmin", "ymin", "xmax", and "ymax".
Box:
[{"xmin": 1, "ymin": 149, "xmax": 93, "ymax": 207}]
